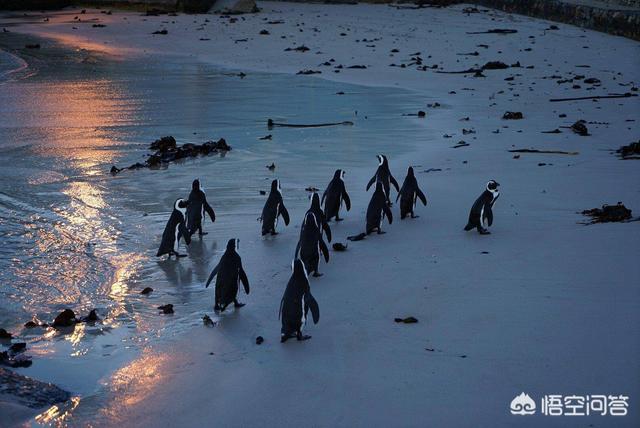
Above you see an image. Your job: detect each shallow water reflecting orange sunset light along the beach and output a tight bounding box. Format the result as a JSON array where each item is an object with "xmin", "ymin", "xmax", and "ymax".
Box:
[{"xmin": 0, "ymin": 35, "xmax": 432, "ymax": 406}]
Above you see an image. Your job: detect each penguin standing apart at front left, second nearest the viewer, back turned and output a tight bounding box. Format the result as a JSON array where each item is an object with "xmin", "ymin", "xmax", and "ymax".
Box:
[{"xmin": 205, "ymin": 239, "xmax": 249, "ymax": 312}]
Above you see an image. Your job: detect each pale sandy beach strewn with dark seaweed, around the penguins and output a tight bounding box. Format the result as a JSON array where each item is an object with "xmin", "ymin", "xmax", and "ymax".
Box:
[{"xmin": 0, "ymin": 2, "xmax": 640, "ymax": 427}]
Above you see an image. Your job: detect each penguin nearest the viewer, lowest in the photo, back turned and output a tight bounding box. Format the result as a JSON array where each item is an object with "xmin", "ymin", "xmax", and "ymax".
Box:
[{"xmin": 278, "ymin": 259, "xmax": 320, "ymax": 343}]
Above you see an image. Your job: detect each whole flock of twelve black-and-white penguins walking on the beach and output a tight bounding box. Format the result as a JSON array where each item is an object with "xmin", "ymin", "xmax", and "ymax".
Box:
[{"xmin": 157, "ymin": 155, "xmax": 500, "ymax": 342}]
